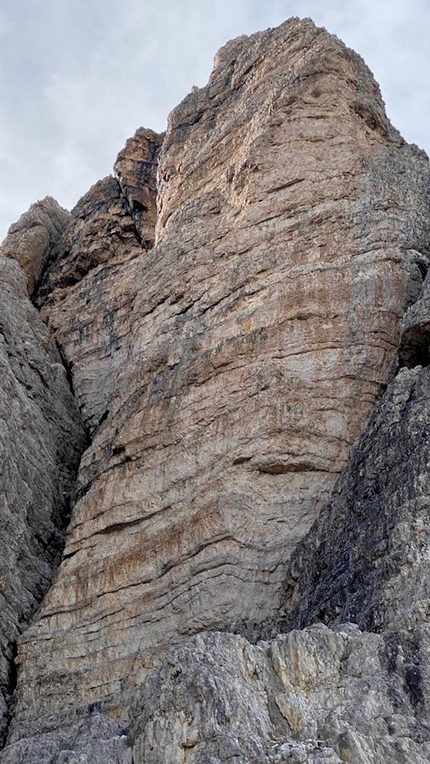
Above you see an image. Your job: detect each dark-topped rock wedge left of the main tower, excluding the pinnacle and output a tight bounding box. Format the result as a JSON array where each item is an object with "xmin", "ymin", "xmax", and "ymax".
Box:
[{"xmin": 39, "ymin": 178, "xmax": 152, "ymax": 435}]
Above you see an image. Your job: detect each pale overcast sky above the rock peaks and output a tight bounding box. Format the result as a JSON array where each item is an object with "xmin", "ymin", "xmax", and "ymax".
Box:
[{"xmin": 0, "ymin": 0, "xmax": 430, "ymax": 240}]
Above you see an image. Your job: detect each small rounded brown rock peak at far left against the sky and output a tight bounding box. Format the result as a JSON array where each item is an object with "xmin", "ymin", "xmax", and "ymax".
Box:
[{"xmin": 1, "ymin": 196, "xmax": 70, "ymax": 296}]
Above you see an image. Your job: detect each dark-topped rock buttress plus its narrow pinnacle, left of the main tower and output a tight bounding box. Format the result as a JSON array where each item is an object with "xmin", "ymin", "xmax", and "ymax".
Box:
[{"xmin": 34, "ymin": 130, "xmax": 160, "ymax": 435}]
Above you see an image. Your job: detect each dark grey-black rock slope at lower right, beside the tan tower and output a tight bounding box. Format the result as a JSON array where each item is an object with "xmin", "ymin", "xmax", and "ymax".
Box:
[{"xmin": 285, "ymin": 366, "xmax": 430, "ymax": 631}]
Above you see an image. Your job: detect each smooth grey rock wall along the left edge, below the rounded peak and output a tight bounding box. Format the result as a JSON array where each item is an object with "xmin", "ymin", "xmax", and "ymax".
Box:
[{"xmin": 0, "ymin": 254, "xmax": 85, "ymax": 744}]
